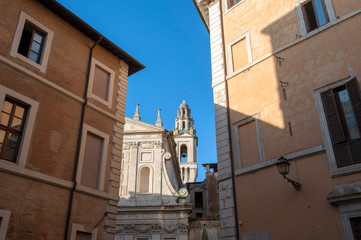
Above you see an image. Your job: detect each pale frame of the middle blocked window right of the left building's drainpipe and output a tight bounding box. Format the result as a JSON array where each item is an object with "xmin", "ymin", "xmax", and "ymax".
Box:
[{"xmin": 76, "ymin": 124, "xmax": 109, "ymax": 192}]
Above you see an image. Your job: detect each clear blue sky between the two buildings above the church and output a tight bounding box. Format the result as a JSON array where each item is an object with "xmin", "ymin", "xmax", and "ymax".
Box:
[{"xmin": 59, "ymin": 0, "xmax": 216, "ymax": 181}]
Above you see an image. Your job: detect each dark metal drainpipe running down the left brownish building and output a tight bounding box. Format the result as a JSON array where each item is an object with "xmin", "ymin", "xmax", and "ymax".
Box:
[{"xmin": 64, "ymin": 37, "xmax": 103, "ymax": 240}]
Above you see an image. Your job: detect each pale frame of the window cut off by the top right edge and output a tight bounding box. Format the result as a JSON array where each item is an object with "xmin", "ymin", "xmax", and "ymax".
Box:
[{"xmin": 295, "ymin": 0, "xmax": 336, "ymax": 36}]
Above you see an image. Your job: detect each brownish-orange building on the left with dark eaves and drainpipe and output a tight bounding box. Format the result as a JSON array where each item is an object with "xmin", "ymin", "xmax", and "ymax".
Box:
[{"xmin": 0, "ymin": 0, "xmax": 144, "ymax": 240}]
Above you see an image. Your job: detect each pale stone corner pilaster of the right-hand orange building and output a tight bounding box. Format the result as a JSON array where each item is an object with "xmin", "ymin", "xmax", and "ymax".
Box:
[{"xmin": 209, "ymin": 0, "xmax": 237, "ymax": 240}]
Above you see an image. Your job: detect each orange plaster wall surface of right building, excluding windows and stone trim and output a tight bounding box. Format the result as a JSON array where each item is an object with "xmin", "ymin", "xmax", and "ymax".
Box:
[{"xmin": 224, "ymin": 0, "xmax": 361, "ymax": 240}]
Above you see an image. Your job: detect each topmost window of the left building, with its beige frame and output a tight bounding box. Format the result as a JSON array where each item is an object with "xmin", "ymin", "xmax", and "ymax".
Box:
[{"xmin": 10, "ymin": 12, "xmax": 54, "ymax": 72}]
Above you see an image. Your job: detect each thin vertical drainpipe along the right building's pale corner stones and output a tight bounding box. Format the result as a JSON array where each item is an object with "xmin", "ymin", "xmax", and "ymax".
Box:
[{"xmin": 219, "ymin": 0, "xmax": 239, "ymax": 239}]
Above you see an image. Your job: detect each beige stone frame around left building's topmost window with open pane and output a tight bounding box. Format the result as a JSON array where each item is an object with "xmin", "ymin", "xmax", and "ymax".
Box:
[{"xmin": 10, "ymin": 11, "xmax": 54, "ymax": 73}]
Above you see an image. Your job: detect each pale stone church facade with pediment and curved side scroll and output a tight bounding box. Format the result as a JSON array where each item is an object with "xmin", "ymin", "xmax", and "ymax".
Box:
[{"xmin": 115, "ymin": 102, "xmax": 197, "ymax": 240}]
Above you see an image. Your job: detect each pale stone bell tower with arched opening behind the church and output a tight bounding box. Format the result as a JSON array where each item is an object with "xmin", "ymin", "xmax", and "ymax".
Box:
[{"xmin": 173, "ymin": 100, "xmax": 198, "ymax": 183}]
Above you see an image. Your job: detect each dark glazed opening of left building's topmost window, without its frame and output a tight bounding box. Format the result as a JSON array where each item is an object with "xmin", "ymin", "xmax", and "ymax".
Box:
[{"xmin": 18, "ymin": 22, "xmax": 46, "ymax": 63}]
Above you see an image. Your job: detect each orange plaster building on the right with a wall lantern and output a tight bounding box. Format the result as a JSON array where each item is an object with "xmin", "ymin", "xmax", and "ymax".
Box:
[{"xmin": 193, "ymin": 0, "xmax": 361, "ymax": 240}]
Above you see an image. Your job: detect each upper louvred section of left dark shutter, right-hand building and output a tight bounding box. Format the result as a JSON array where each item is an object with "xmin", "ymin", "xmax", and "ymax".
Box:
[{"xmin": 321, "ymin": 89, "xmax": 346, "ymax": 145}]
